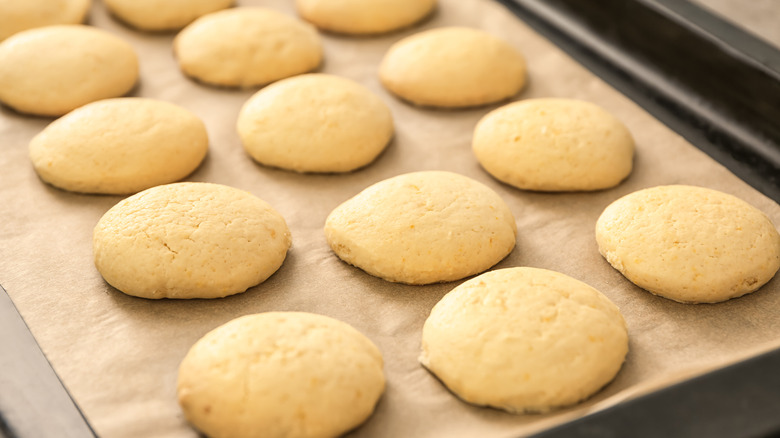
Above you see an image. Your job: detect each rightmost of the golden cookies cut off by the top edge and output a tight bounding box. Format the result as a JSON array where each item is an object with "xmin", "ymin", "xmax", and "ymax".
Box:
[{"xmin": 295, "ymin": 0, "xmax": 436, "ymax": 35}]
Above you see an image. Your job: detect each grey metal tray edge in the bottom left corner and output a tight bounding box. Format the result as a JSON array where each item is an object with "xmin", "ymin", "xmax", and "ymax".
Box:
[{"xmin": 0, "ymin": 286, "xmax": 95, "ymax": 438}]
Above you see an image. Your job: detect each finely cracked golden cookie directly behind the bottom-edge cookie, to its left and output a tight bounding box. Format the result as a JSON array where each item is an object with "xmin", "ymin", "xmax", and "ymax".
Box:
[{"xmin": 92, "ymin": 183, "xmax": 290, "ymax": 299}]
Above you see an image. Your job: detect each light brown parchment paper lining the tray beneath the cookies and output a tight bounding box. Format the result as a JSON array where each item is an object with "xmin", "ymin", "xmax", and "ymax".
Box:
[{"xmin": 0, "ymin": 0, "xmax": 780, "ymax": 437}]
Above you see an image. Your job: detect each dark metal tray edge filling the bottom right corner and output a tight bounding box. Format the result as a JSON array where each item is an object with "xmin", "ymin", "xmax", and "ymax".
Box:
[{"xmin": 535, "ymin": 351, "xmax": 780, "ymax": 438}]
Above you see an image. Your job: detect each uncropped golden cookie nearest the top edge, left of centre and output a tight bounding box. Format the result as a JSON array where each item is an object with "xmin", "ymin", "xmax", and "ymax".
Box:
[{"xmin": 173, "ymin": 7, "xmax": 322, "ymax": 87}]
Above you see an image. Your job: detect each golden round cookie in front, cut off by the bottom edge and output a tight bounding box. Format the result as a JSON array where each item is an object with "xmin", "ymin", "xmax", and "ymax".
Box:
[{"xmin": 178, "ymin": 312, "xmax": 385, "ymax": 438}]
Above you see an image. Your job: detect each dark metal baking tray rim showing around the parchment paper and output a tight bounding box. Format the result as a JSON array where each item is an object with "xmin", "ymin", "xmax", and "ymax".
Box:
[{"xmin": 0, "ymin": 0, "xmax": 780, "ymax": 438}]
